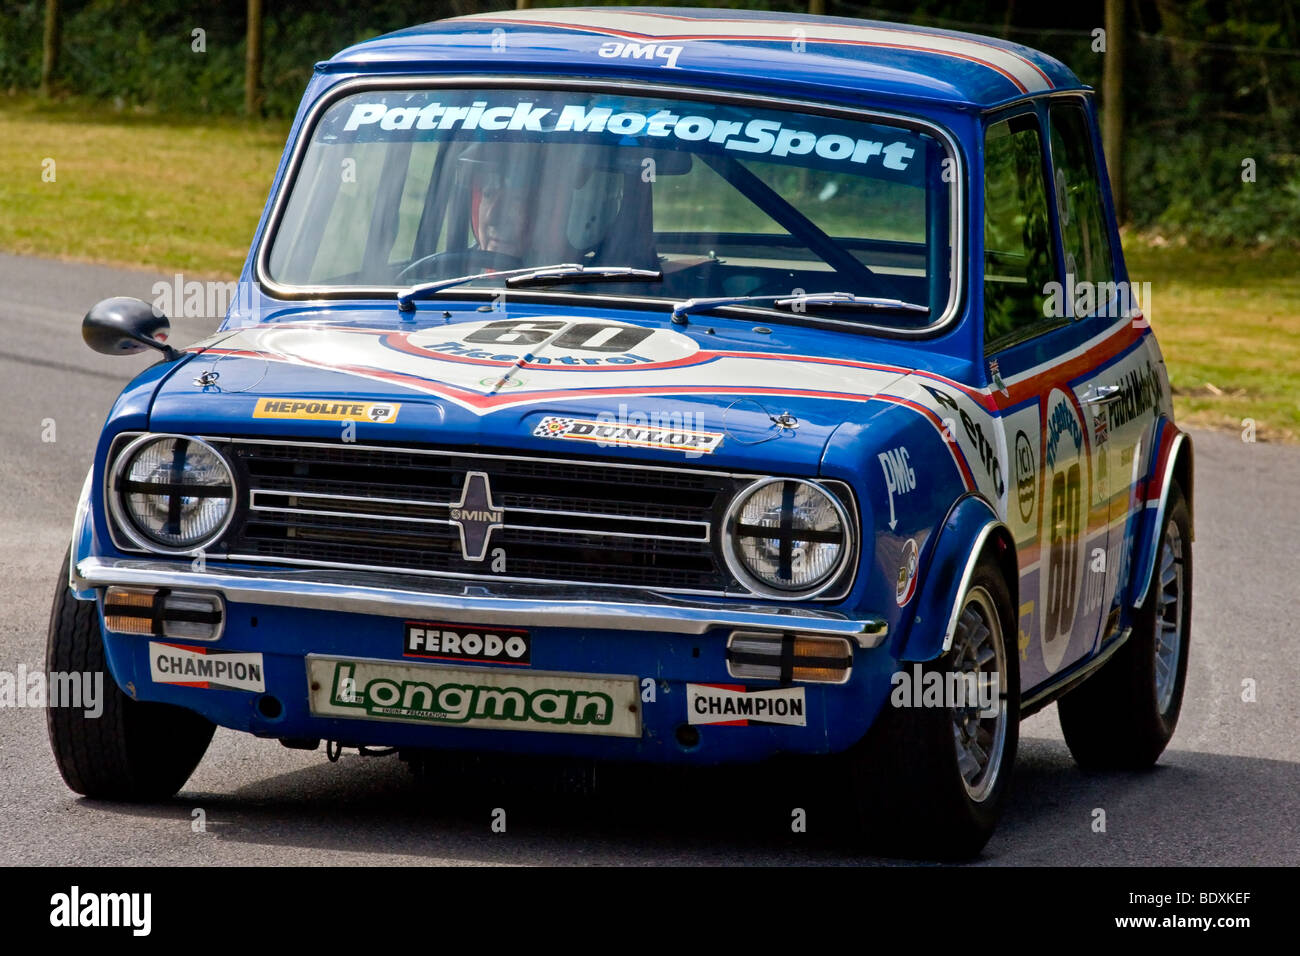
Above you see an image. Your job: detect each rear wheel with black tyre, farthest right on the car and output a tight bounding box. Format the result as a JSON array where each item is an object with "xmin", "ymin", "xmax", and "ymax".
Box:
[{"xmin": 1057, "ymin": 485, "xmax": 1192, "ymax": 770}]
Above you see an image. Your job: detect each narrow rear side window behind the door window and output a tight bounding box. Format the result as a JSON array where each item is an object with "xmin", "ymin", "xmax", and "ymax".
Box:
[{"xmin": 1050, "ymin": 104, "xmax": 1114, "ymax": 315}]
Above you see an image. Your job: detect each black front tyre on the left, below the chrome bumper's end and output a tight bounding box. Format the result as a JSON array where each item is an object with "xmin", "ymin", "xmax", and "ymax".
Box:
[{"xmin": 46, "ymin": 558, "xmax": 216, "ymax": 801}]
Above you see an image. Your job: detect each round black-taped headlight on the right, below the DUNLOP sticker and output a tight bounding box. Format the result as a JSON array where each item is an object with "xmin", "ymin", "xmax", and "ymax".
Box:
[{"xmin": 724, "ymin": 479, "xmax": 853, "ymax": 597}]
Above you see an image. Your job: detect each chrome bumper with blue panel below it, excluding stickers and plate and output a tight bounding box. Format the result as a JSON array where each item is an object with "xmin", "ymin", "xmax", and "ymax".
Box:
[{"xmin": 73, "ymin": 557, "xmax": 896, "ymax": 763}]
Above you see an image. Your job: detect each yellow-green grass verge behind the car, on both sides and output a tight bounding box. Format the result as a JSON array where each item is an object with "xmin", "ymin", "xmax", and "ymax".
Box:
[{"xmin": 0, "ymin": 96, "xmax": 1300, "ymax": 441}]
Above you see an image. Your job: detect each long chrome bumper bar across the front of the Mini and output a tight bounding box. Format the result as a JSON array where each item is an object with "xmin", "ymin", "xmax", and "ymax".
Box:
[{"xmin": 73, "ymin": 558, "xmax": 888, "ymax": 648}]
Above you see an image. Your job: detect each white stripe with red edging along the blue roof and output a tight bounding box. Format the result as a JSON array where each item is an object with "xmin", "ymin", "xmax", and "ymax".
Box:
[{"xmin": 456, "ymin": 9, "xmax": 1052, "ymax": 92}]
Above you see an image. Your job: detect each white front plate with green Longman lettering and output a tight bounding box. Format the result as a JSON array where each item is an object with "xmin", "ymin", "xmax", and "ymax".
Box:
[{"xmin": 307, "ymin": 654, "xmax": 641, "ymax": 737}]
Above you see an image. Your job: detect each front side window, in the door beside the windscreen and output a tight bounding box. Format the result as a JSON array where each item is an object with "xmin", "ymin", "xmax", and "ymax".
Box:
[{"xmin": 984, "ymin": 113, "xmax": 1060, "ymax": 351}]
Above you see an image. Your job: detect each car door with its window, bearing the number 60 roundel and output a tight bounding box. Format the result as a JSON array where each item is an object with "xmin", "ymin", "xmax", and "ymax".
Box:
[{"xmin": 982, "ymin": 103, "xmax": 1109, "ymax": 691}]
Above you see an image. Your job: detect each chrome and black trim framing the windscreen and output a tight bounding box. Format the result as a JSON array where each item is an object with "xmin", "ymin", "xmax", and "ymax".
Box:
[{"xmin": 254, "ymin": 74, "xmax": 966, "ymax": 337}]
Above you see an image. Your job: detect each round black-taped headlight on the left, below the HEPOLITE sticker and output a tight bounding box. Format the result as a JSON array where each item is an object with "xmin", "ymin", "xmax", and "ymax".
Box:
[{"xmin": 111, "ymin": 436, "xmax": 234, "ymax": 551}]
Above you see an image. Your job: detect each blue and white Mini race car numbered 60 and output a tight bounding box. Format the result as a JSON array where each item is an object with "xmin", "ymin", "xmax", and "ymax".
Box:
[{"xmin": 49, "ymin": 8, "xmax": 1192, "ymax": 856}]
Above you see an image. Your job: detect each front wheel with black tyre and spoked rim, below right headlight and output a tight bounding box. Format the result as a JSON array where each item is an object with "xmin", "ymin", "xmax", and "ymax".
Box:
[{"xmin": 848, "ymin": 559, "xmax": 1021, "ymax": 860}]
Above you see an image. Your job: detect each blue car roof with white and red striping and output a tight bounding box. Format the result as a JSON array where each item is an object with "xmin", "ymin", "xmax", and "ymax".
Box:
[{"xmin": 327, "ymin": 7, "xmax": 1086, "ymax": 109}]
